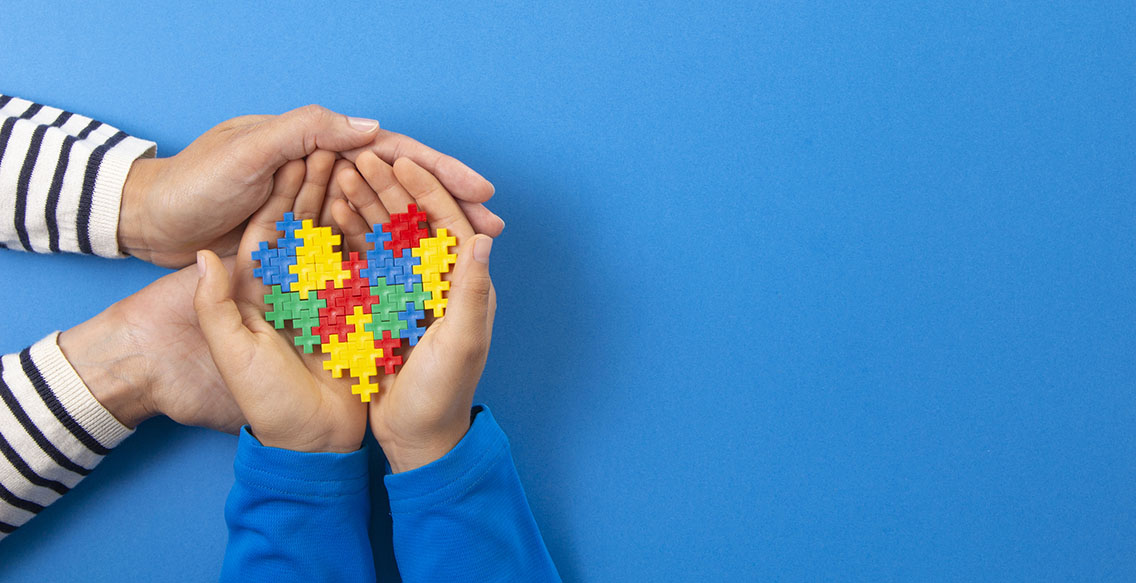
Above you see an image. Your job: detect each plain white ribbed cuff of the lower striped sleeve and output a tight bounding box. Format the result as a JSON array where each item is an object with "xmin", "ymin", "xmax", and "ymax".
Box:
[{"xmin": 30, "ymin": 332, "xmax": 134, "ymax": 449}]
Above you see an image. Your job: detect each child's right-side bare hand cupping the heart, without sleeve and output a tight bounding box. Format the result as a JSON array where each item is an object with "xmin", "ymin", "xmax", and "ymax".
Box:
[{"xmin": 332, "ymin": 153, "xmax": 496, "ymax": 473}]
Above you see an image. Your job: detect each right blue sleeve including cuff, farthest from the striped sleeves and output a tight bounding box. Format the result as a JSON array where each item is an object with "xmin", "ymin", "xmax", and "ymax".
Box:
[{"xmin": 385, "ymin": 406, "xmax": 560, "ymax": 583}]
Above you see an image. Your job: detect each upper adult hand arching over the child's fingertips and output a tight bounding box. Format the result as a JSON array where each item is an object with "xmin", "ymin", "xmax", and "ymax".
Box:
[{"xmin": 118, "ymin": 106, "xmax": 504, "ymax": 267}]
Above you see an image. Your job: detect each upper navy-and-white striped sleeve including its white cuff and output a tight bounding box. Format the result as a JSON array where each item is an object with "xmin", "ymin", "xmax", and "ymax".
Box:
[{"xmin": 0, "ymin": 94, "xmax": 156, "ymax": 257}]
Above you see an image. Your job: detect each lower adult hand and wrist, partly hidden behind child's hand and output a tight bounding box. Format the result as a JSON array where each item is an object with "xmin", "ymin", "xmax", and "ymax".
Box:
[{"xmin": 59, "ymin": 260, "xmax": 244, "ymax": 433}]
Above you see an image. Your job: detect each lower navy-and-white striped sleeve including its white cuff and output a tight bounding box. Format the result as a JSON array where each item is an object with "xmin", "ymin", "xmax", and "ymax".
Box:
[{"xmin": 0, "ymin": 332, "xmax": 133, "ymax": 539}]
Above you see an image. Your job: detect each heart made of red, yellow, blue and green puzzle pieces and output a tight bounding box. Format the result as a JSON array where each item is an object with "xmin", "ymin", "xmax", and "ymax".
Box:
[{"xmin": 252, "ymin": 205, "xmax": 458, "ymax": 402}]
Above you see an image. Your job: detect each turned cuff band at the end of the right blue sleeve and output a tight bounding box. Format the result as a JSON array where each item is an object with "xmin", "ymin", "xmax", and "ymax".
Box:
[{"xmin": 384, "ymin": 405, "xmax": 512, "ymax": 514}]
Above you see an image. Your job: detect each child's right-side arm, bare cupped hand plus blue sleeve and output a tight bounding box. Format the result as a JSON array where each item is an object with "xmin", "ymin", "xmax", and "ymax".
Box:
[{"xmin": 333, "ymin": 157, "xmax": 559, "ymax": 582}]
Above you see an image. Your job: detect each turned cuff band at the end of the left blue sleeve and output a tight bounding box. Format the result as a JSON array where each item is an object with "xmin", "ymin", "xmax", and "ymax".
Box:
[{"xmin": 233, "ymin": 425, "xmax": 369, "ymax": 498}]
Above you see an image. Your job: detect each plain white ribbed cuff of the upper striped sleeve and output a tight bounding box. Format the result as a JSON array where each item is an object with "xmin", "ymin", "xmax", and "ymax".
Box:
[{"xmin": 90, "ymin": 136, "xmax": 158, "ymax": 257}]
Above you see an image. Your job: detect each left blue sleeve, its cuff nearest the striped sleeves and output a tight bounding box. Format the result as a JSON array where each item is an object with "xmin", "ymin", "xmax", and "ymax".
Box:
[{"xmin": 220, "ymin": 426, "xmax": 375, "ymax": 583}]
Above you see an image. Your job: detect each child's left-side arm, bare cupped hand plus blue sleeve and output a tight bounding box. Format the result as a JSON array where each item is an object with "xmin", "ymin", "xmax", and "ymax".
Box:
[{"xmin": 194, "ymin": 152, "xmax": 375, "ymax": 583}]
